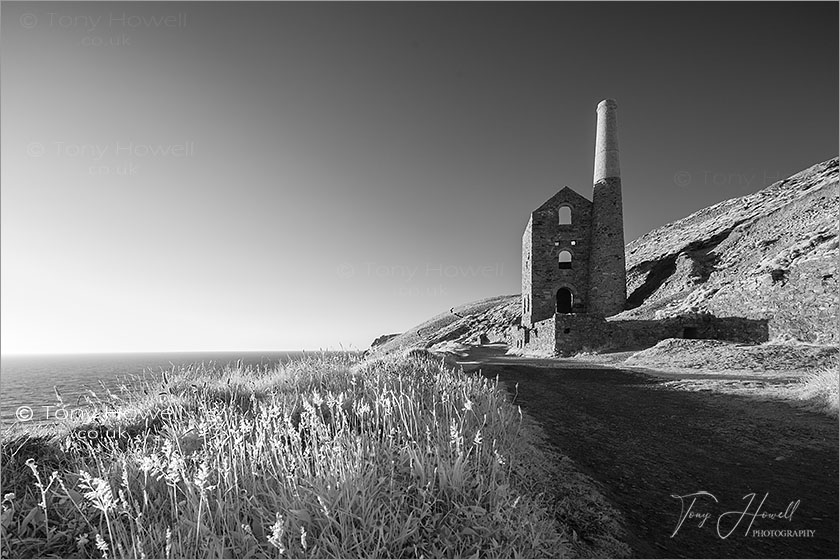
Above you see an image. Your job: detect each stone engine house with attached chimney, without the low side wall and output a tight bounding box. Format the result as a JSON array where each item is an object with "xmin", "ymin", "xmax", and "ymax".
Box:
[{"xmin": 518, "ymin": 99, "xmax": 627, "ymax": 353}]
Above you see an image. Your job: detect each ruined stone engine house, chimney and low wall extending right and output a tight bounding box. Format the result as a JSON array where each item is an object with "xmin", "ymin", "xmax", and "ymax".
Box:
[{"xmin": 510, "ymin": 99, "xmax": 767, "ymax": 355}]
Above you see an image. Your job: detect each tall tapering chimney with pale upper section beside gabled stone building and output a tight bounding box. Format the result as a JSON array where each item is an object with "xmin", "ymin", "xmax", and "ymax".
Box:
[{"xmin": 589, "ymin": 99, "xmax": 627, "ymax": 317}]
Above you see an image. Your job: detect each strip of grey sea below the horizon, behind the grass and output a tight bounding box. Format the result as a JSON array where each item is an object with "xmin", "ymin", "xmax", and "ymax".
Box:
[{"xmin": 0, "ymin": 352, "xmax": 328, "ymax": 425}]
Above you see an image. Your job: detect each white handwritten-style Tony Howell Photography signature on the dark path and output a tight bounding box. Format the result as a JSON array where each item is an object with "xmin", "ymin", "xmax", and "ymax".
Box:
[{"xmin": 671, "ymin": 490, "xmax": 814, "ymax": 539}]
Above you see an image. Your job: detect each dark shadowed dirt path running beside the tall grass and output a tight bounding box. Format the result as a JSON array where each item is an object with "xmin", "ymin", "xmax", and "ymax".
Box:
[{"xmin": 458, "ymin": 348, "xmax": 838, "ymax": 558}]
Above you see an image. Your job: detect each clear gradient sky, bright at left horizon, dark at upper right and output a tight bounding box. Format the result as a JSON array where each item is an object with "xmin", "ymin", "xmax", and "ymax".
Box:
[{"xmin": 0, "ymin": 2, "xmax": 839, "ymax": 354}]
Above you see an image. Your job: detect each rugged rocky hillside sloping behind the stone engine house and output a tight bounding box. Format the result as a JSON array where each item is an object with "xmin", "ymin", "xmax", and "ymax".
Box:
[{"xmin": 378, "ymin": 158, "xmax": 840, "ymax": 351}]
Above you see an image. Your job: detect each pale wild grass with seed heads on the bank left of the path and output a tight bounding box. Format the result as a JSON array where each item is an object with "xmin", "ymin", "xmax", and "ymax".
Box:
[{"xmin": 2, "ymin": 355, "xmax": 600, "ymax": 558}]
